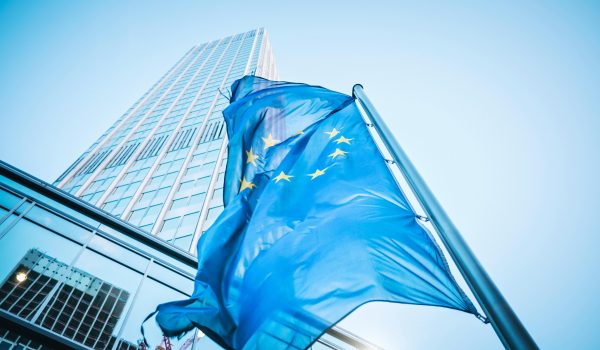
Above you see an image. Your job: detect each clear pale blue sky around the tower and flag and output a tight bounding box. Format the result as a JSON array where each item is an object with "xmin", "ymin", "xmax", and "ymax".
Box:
[{"xmin": 0, "ymin": 0, "xmax": 600, "ymax": 349}]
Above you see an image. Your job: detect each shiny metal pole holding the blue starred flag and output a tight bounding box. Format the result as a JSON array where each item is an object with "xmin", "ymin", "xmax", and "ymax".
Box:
[{"xmin": 352, "ymin": 84, "xmax": 538, "ymax": 349}]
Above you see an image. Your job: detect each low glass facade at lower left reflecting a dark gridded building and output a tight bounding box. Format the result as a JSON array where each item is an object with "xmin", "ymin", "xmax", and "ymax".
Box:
[{"xmin": 0, "ymin": 163, "xmax": 202, "ymax": 349}]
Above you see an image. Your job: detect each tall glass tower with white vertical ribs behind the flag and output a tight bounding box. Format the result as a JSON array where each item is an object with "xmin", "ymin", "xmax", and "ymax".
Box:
[{"xmin": 55, "ymin": 28, "xmax": 277, "ymax": 252}]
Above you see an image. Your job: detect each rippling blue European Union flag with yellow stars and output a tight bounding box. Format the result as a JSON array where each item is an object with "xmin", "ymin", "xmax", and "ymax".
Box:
[{"xmin": 151, "ymin": 76, "xmax": 477, "ymax": 349}]
